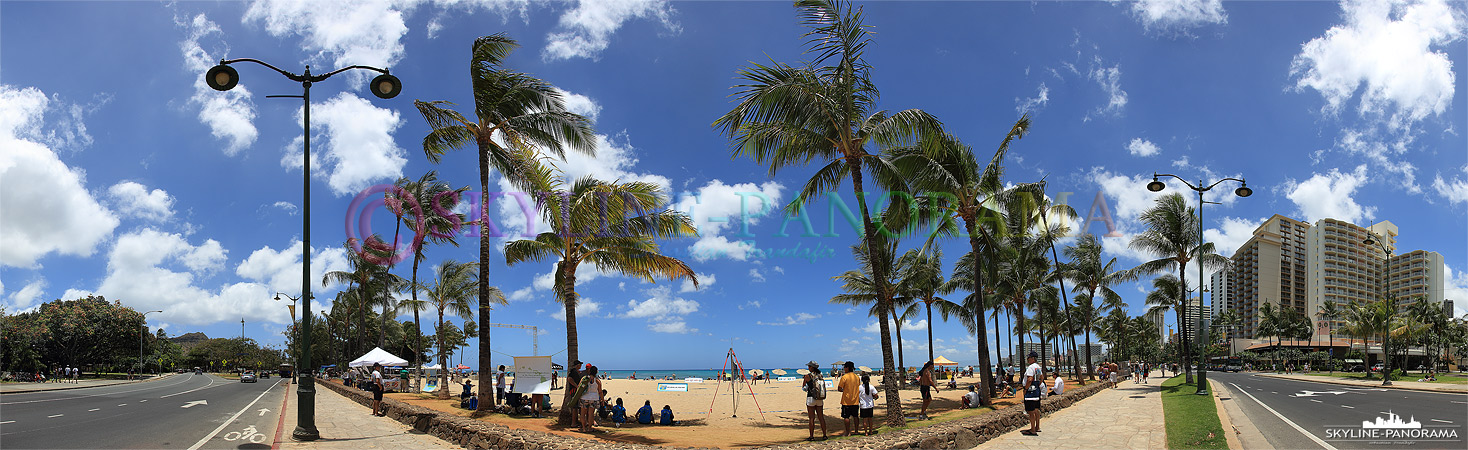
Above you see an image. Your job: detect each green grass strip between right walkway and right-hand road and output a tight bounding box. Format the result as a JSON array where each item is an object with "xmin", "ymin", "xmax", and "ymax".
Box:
[{"xmin": 1163, "ymin": 377, "xmax": 1229, "ymax": 449}]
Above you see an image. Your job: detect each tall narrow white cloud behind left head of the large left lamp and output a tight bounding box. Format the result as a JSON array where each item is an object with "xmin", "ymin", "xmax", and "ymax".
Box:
[{"xmin": 175, "ymin": 15, "xmax": 260, "ymax": 155}]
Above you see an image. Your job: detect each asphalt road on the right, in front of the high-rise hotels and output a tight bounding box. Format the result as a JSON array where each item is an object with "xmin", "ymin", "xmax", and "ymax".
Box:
[{"xmin": 1208, "ymin": 372, "xmax": 1468, "ymax": 449}]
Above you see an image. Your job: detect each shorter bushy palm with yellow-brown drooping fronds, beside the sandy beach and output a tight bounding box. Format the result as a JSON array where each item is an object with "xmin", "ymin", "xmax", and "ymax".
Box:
[{"xmin": 505, "ymin": 177, "xmax": 699, "ymax": 424}]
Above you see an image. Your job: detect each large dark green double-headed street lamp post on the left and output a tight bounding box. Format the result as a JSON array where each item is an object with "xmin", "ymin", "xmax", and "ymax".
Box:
[{"xmin": 204, "ymin": 57, "xmax": 402, "ymax": 441}]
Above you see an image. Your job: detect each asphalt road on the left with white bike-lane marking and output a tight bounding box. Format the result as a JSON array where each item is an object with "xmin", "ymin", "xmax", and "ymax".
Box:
[{"xmin": 0, "ymin": 374, "xmax": 288, "ymax": 449}]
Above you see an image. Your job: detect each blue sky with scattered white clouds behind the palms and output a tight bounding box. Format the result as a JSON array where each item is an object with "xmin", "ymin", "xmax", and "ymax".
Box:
[{"xmin": 0, "ymin": 0, "xmax": 1468, "ymax": 368}]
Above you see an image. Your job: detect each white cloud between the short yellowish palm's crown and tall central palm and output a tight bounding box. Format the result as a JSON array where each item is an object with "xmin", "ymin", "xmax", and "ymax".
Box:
[{"xmin": 674, "ymin": 180, "xmax": 784, "ymax": 262}]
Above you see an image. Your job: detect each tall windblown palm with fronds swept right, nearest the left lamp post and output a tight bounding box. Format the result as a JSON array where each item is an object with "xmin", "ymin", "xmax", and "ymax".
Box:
[{"xmin": 413, "ymin": 34, "xmax": 596, "ymax": 410}]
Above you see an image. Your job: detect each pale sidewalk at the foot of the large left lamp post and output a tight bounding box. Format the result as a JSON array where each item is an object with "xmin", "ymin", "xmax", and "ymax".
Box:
[{"xmin": 275, "ymin": 386, "xmax": 458, "ymax": 450}]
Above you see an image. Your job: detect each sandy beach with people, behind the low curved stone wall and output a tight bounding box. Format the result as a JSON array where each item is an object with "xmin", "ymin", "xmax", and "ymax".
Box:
[{"xmin": 389, "ymin": 377, "xmax": 1033, "ymax": 449}]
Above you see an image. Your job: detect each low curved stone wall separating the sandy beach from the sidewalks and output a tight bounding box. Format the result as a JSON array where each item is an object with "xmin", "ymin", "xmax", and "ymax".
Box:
[{"xmin": 316, "ymin": 378, "xmax": 1111, "ymax": 450}]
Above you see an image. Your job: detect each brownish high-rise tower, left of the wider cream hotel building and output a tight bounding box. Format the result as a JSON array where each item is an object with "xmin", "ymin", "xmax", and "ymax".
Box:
[{"xmin": 1229, "ymin": 214, "xmax": 1309, "ymax": 339}]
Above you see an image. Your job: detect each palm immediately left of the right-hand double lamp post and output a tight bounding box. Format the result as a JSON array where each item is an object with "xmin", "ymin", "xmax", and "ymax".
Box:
[{"xmin": 1130, "ymin": 193, "xmax": 1229, "ymax": 384}]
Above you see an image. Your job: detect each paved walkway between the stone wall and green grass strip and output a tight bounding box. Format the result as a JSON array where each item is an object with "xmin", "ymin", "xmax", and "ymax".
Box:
[{"xmin": 975, "ymin": 372, "xmax": 1167, "ymax": 450}]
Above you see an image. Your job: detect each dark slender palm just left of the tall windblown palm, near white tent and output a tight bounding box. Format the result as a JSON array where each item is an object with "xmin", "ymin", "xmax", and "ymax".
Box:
[{"xmin": 386, "ymin": 170, "xmax": 468, "ymax": 389}]
